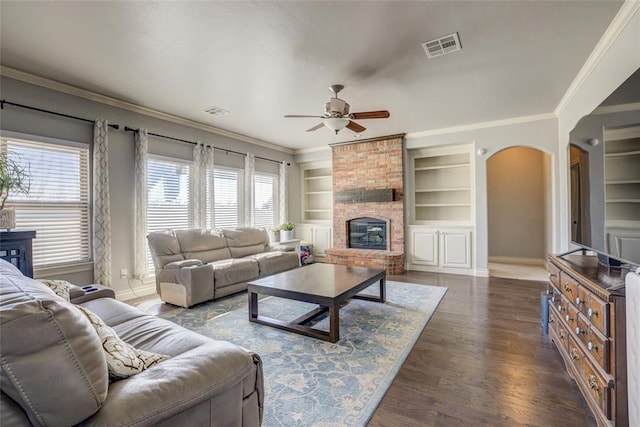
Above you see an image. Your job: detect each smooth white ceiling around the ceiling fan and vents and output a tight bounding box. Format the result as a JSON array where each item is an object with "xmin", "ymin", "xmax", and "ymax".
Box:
[{"xmin": 0, "ymin": 0, "xmax": 622, "ymax": 150}]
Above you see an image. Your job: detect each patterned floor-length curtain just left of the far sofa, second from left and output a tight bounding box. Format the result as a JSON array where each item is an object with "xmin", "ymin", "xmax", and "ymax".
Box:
[{"xmin": 133, "ymin": 129, "xmax": 148, "ymax": 280}]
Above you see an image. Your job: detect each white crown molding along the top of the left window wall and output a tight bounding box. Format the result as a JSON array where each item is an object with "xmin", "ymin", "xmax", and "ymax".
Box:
[{"xmin": 0, "ymin": 65, "xmax": 294, "ymax": 154}]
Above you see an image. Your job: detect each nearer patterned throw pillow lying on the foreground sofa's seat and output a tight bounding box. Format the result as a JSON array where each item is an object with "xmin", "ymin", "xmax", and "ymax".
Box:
[{"xmin": 76, "ymin": 305, "xmax": 170, "ymax": 380}]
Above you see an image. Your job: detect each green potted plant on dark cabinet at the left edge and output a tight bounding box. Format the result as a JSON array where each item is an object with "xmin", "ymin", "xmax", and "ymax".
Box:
[{"xmin": 0, "ymin": 152, "xmax": 31, "ymax": 230}]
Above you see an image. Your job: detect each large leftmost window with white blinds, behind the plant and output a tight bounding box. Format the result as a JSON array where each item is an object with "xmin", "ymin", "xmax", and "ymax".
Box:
[{"xmin": 0, "ymin": 138, "xmax": 91, "ymax": 267}]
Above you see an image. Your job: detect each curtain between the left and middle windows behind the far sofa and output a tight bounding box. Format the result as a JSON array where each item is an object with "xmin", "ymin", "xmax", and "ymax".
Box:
[{"xmin": 191, "ymin": 142, "xmax": 215, "ymax": 229}]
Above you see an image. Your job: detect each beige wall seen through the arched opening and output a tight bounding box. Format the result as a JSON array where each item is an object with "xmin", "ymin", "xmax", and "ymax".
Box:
[{"xmin": 487, "ymin": 147, "xmax": 547, "ymax": 259}]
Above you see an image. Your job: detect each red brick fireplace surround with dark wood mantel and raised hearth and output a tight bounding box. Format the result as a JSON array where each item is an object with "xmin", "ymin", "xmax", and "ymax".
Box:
[{"xmin": 326, "ymin": 134, "xmax": 405, "ymax": 274}]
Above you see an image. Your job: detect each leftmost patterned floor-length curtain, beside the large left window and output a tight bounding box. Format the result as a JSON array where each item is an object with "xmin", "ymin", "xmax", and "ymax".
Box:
[{"xmin": 92, "ymin": 119, "xmax": 111, "ymax": 286}]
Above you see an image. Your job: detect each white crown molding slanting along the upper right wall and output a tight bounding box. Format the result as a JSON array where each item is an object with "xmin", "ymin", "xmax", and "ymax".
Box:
[{"xmin": 554, "ymin": 0, "xmax": 640, "ymax": 117}]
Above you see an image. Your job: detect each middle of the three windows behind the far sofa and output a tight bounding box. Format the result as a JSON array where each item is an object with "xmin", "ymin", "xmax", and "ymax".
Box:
[{"xmin": 207, "ymin": 167, "xmax": 243, "ymax": 228}]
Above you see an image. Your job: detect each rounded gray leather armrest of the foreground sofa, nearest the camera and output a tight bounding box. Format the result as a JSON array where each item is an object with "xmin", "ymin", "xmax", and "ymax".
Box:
[{"xmin": 81, "ymin": 341, "xmax": 264, "ymax": 426}]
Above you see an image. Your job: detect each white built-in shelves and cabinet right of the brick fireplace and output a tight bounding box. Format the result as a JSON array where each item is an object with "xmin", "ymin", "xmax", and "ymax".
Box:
[{"xmin": 406, "ymin": 145, "xmax": 474, "ymax": 274}]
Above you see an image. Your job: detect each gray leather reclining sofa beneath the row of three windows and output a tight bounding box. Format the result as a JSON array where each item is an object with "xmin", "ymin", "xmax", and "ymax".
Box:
[{"xmin": 147, "ymin": 228, "xmax": 300, "ymax": 307}]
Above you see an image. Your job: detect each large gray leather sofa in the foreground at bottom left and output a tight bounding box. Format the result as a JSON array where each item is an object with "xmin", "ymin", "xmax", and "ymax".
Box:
[{"xmin": 0, "ymin": 259, "xmax": 264, "ymax": 427}]
